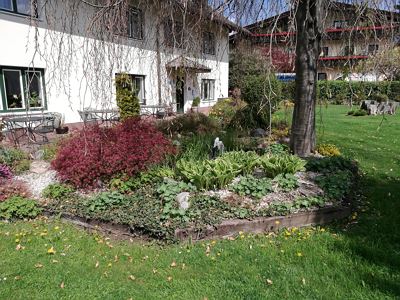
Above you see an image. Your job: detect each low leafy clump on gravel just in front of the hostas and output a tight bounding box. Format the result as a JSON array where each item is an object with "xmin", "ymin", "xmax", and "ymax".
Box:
[{"xmin": 229, "ymin": 175, "xmax": 272, "ymax": 199}]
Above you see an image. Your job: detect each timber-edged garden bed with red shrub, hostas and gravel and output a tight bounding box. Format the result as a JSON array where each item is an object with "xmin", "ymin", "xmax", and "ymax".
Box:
[{"xmin": 0, "ymin": 116, "xmax": 358, "ymax": 241}]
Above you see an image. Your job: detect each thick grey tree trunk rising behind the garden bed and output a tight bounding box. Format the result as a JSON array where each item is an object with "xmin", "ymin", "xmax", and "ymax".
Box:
[{"xmin": 290, "ymin": 0, "xmax": 324, "ymax": 157}]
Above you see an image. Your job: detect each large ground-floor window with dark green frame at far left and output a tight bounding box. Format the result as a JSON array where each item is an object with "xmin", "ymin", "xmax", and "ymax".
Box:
[{"xmin": 0, "ymin": 66, "xmax": 45, "ymax": 111}]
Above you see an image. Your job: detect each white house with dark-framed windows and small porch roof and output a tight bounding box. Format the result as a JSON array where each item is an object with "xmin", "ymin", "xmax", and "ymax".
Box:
[{"xmin": 0, "ymin": 0, "xmax": 232, "ymax": 123}]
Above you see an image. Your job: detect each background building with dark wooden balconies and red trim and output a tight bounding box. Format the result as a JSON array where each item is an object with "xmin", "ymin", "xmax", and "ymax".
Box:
[{"xmin": 241, "ymin": 1, "xmax": 400, "ymax": 80}]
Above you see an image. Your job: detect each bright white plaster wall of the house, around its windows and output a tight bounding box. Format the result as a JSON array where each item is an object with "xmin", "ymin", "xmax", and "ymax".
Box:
[{"xmin": 0, "ymin": 0, "xmax": 229, "ymax": 123}]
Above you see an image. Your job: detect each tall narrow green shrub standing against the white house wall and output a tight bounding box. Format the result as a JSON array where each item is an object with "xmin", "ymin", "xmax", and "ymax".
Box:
[{"xmin": 115, "ymin": 74, "xmax": 140, "ymax": 120}]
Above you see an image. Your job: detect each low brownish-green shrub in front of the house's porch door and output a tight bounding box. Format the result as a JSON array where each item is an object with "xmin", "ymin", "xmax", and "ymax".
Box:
[{"xmin": 157, "ymin": 112, "xmax": 218, "ymax": 136}]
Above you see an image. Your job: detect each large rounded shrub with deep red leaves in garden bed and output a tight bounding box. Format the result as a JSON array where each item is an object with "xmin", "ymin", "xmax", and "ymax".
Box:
[{"xmin": 52, "ymin": 118, "xmax": 175, "ymax": 188}]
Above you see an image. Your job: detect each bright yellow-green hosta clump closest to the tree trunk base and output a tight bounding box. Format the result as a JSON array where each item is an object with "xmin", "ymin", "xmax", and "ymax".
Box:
[{"xmin": 260, "ymin": 154, "xmax": 306, "ymax": 178}]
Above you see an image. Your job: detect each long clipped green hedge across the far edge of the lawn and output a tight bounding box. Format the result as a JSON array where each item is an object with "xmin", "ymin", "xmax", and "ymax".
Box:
[{"xmin": 282, "ymin": 80, "xmax": 400, "ymax": 104}]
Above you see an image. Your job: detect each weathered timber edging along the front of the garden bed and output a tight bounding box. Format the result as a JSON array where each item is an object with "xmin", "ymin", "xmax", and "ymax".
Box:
[{"xmin": 41, "ymin": 206, "xmax": 351, "ymax": 241}]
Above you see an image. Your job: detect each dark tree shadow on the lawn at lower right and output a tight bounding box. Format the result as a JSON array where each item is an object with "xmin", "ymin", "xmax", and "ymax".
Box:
[{"xmin": 336, "ymin": 177, "xmax": 400, "ymax": 297}]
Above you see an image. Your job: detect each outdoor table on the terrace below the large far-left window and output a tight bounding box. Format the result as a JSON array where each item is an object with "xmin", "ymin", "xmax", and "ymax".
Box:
[{"xmin": 4, "ymin": 114, "xmax": 55, "ymax": 145}]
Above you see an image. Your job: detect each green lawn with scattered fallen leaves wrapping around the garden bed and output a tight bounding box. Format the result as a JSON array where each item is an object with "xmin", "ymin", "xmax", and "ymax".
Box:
[{"xmin": 0, "ymin": 106, "xmax": 400, "ymax": 299}]
